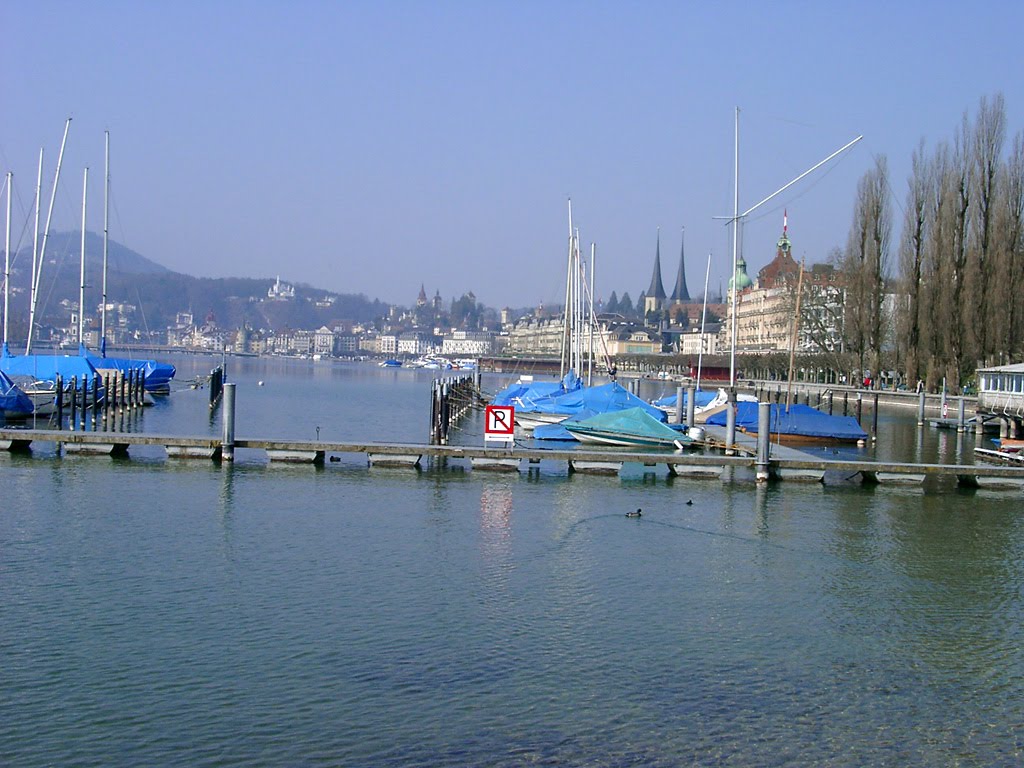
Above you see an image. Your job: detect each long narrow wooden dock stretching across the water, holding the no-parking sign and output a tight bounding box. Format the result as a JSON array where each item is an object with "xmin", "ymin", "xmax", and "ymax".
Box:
[{"xmin": 0, "ymin": 429, "xmax": 1024, "ymax": 490}]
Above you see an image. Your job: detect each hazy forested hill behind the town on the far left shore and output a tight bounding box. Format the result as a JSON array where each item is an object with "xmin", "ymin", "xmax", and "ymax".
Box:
[{"xmin": 4, "ymin": 232, "xmax": 387, "ymax": 331}]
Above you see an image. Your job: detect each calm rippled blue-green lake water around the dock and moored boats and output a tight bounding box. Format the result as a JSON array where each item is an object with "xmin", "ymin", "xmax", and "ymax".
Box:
[{"xmin": 0, "ymin": 357, "xmax": 1024, "ymax": 766}]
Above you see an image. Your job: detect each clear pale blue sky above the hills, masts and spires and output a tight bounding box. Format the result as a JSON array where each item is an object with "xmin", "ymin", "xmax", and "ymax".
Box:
[{"xmin": 0, "ymin": 0, "xmax": 1024, "ymax": 307}]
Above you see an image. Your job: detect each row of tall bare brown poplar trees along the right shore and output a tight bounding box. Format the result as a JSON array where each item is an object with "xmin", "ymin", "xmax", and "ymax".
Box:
[{"xmin": 841, "ymin": 95, "xmax": 1024, "ymax": 389}]
